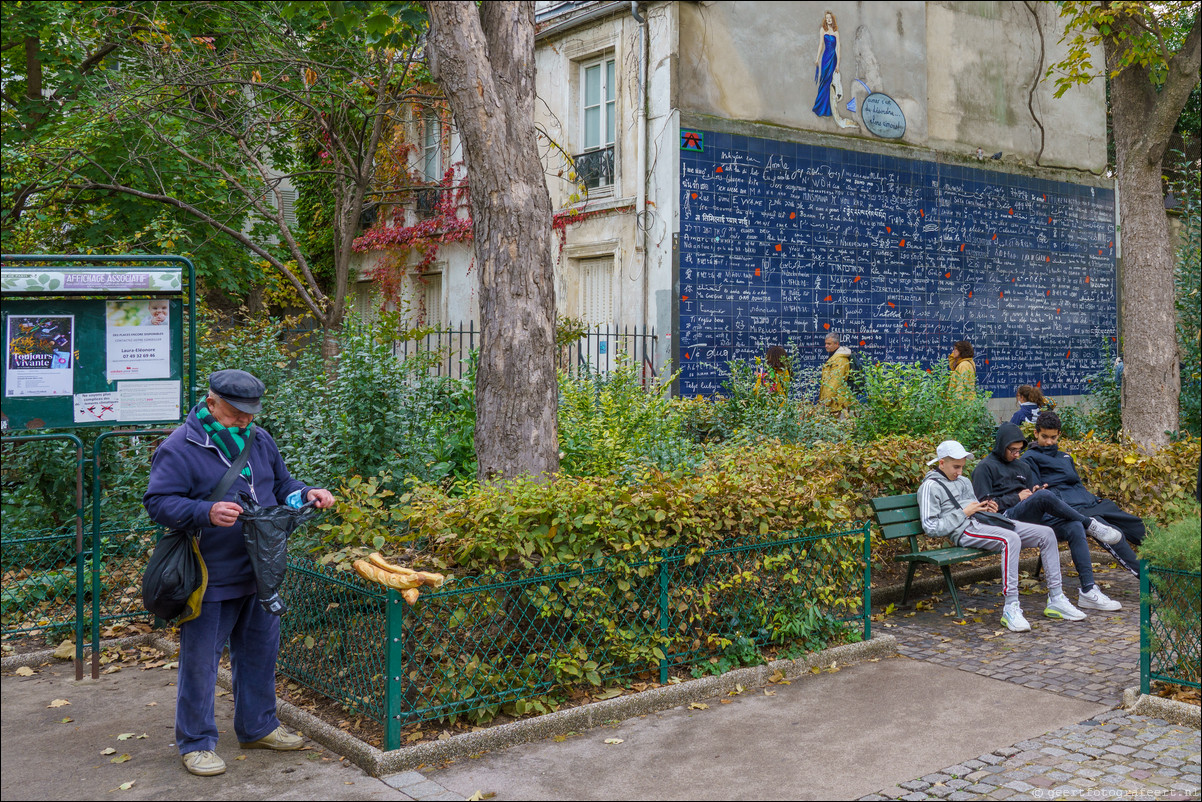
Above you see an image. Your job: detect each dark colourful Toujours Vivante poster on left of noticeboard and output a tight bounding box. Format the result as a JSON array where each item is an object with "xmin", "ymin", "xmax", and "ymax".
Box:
[{"xmin": 4, "ymin": 315, "xmax": 75, "ymax": 398}]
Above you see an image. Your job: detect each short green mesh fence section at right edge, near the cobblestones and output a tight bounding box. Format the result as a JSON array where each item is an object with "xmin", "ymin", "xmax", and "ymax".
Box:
[{"xmin": 1139, "ymin": 560, "xmax": 1202, "ymax": 694}]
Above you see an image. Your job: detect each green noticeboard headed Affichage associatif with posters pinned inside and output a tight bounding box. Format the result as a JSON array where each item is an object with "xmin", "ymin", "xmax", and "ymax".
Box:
[{"xmin": 0, "ymin": 254, "xmax": 196, "ymax": 434}]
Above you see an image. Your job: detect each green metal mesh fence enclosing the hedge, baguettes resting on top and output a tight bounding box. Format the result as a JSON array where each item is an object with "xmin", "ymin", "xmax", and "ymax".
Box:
[{"xmin": 279, "ymin": 524, "xmax": 871, "ymax": 749}]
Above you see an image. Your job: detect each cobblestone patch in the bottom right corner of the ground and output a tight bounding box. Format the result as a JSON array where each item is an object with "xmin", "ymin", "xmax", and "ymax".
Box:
[{"xmin": 861, "ymin": 711, "xmax": 1200, "ymax": 800}]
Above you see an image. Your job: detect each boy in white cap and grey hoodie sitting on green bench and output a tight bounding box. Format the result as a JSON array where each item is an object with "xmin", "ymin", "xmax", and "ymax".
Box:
[{"xmin": 918, "ymin": 440, "xmax": 1085, "ymax": 632}]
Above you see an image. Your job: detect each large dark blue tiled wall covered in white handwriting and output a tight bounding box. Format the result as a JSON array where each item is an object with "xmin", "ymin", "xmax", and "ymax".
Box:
[{"xmin": 674, "ymin": 131, "xmax": 1117, "ymax": 396}]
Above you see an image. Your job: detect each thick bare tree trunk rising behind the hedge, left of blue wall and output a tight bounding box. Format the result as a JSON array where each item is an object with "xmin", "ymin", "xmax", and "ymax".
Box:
[{"xmin": 426, "ymin": 0, "xmax": 559, "ymax": 481}]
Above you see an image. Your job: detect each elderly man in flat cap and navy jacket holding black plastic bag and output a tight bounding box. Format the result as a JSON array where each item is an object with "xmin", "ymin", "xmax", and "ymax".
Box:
[{"xmin": 142, "ymin": 370, "xmax": 334, "ymax": 777}]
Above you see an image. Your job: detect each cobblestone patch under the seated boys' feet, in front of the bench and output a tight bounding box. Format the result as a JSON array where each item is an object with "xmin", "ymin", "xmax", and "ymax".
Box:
[{"xmin": 889, "ymin": 552, "xmax": 1139, "ymax": 705}]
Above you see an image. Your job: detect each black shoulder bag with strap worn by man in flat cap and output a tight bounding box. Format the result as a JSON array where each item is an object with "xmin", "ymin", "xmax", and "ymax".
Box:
[{"xmin": 142, "ymin": 429, "xmax": 257, "ymax": 624}]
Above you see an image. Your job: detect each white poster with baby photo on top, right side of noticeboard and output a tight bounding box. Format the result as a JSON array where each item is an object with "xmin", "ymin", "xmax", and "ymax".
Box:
[{"xmin": 105, "ymin": 299, "xmax": 171, "ymax": 381}]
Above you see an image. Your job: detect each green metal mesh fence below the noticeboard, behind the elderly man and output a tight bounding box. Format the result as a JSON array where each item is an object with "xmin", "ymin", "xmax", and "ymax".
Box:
[{"xmin": 0, "ymin": 429, "xmax": 169, "ymax": 678}]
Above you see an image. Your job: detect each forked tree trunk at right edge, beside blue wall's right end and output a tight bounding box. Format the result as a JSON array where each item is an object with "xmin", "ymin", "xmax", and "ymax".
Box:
[{"xmin": 1105, "ymin": 17, "xmax": 1200, "ymax": 450}]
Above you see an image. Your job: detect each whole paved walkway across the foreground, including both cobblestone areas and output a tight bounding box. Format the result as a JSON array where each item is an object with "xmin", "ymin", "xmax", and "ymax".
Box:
[{"xmin": 0, "ymin": 555, "xmax": 1200, "ymax": 800}]
